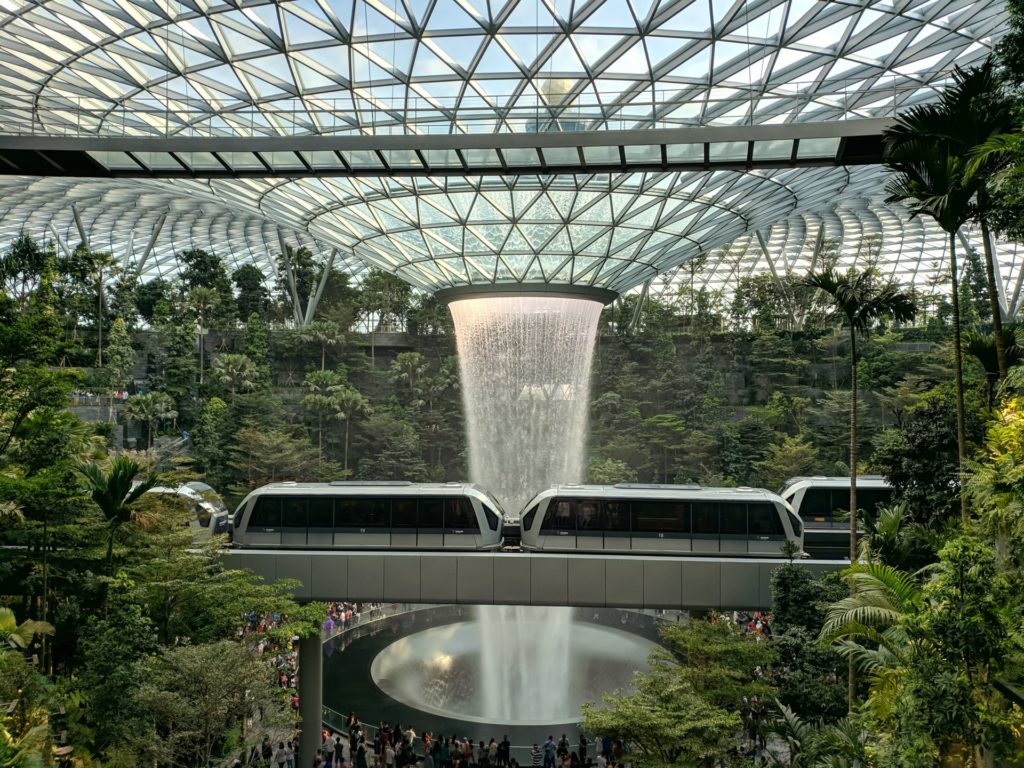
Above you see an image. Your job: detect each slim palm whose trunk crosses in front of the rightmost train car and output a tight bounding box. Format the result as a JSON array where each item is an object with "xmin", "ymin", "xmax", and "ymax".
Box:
[{"xmin": 803, "ymin": 268, "xmax": 918, "ymax": 562}]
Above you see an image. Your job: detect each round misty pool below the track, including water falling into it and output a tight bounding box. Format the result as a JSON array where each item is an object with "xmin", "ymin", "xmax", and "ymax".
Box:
[{"xmin": 370, "ymin": 606, "xmax": 654, "ymax": 725}]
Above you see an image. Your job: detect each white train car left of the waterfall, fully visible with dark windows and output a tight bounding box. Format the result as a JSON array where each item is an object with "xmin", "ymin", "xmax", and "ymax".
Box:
[{"xmin": 231, "ymin": 481, "xmax": 503, "ymax": 549}]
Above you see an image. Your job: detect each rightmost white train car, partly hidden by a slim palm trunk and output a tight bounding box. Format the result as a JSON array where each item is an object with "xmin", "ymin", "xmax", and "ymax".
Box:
[{"xmin": 779, "ymin": 475, "xmax": 893, "ymax": 557}]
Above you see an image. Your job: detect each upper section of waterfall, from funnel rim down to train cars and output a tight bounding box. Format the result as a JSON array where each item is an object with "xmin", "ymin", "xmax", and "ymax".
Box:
[{"xmin": 449, "ymin": 295, "xmax": 601, "ymax": 514}]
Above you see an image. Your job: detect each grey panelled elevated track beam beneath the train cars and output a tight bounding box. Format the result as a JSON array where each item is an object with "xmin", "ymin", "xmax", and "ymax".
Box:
[{"xmin": 223, "ymin": 550, "xmax": 846, "ymax": 609}]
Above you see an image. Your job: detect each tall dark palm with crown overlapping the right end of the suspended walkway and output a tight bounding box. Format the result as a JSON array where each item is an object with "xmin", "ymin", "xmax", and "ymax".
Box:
[{"xmin": 884, "ymin": 123, "xmax": 976, "ymax": 521}]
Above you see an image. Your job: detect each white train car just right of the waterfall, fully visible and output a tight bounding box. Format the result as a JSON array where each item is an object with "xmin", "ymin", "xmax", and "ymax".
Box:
[{"xmin": 520, "ymin": 483, "xmax": 803, "ymax": 556}]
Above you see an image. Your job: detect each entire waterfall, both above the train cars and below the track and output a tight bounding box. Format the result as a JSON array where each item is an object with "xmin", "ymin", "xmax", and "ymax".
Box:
[{"xmin": 449, "ymin": 295, "xmax": 602, "ymax": 722}]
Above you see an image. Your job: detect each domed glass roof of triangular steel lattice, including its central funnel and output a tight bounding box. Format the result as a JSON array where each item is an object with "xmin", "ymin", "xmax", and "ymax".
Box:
[{"xmin": 0, "ymin": 0, "xmax": 1013, "ymax": 307}]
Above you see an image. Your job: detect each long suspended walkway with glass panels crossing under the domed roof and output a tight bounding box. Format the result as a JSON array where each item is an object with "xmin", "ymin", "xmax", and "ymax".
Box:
[{"xmin": 0, "ymin": 118, "xmax": 892, "ymax": 178}]
